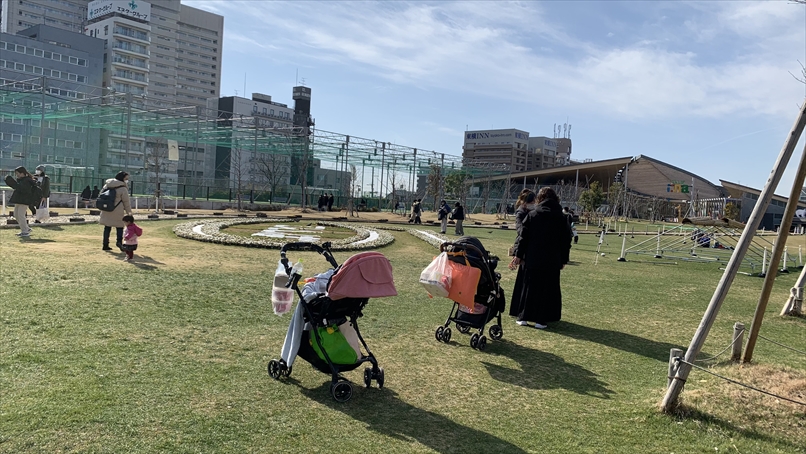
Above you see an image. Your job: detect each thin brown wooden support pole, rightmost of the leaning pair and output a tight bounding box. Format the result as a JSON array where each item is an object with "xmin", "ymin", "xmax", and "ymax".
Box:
[{"xmin": 742, "ymin": 138, "xmax": 806, "ymax": 363}]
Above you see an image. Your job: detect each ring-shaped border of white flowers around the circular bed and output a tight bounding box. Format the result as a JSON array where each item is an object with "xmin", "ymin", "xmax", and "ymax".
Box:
[{"xmin": 173, "ymin": 218, "xmax": 395, "ymax": 251}]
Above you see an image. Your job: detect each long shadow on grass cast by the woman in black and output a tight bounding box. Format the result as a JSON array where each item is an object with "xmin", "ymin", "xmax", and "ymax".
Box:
[{"xmin": 551, "ymin": 321, "xmax": 684, "ymax": 362}]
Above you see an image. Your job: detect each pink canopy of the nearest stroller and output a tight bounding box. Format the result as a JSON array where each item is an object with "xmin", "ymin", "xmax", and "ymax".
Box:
[{"xmin": 327, "ymin": 252, "xmax": 397, "ymax": 300}]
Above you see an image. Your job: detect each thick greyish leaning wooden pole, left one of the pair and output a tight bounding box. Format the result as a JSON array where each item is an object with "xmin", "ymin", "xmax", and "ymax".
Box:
[{"xmin": 661, "ymin": 96, "xmax": 806, "ymax": 412}]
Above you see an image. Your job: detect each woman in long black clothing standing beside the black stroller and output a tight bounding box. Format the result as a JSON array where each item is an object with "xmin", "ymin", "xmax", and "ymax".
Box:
[{"xmin": 509, "ymin": 187, "xmax": 571, "ymax": 329}]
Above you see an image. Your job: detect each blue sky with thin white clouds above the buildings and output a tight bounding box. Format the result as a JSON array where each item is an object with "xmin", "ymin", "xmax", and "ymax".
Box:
[{"xmin": 188, "ymin": 0, "xmax": 806, "ymax": 195}]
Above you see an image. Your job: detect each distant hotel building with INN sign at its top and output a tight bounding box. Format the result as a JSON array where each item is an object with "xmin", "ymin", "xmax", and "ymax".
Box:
[{"xmin": 462, "ymin": 129, "xmax": 529, "ymax": 172}]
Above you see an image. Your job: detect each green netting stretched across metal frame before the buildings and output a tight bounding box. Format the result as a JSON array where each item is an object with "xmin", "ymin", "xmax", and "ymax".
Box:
[{"xmin": 0, "ymin": 79, "xmax": 508, "ymax": 178}]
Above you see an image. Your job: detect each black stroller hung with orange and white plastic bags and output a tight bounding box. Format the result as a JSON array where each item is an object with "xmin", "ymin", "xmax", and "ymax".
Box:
[{"xmin": 434, "ymin": 236, "xmax": 506, "ymax": 350}]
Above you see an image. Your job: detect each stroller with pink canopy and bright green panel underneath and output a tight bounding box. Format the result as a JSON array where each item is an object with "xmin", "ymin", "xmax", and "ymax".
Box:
[{"xmin": 268, "ymin": 243, "xmax": 397, "ymax": 402}]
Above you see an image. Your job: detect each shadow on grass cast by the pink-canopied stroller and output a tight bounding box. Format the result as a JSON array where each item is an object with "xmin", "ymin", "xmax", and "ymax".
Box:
[{"xmin": 302, "ymin": 381, "xmax": 526, "ymax": 453}]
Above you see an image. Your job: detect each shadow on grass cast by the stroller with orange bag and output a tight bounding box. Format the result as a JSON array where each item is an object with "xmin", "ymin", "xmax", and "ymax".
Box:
[{"xmin": 481, "ymin": 340, "xmax": 613, "ymax": 399}]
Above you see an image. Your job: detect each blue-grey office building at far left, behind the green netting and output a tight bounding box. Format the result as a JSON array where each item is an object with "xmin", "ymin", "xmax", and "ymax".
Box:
[{"xmin": 0, "ymin": 25, "xmax": 104, "ymax": 176}]
